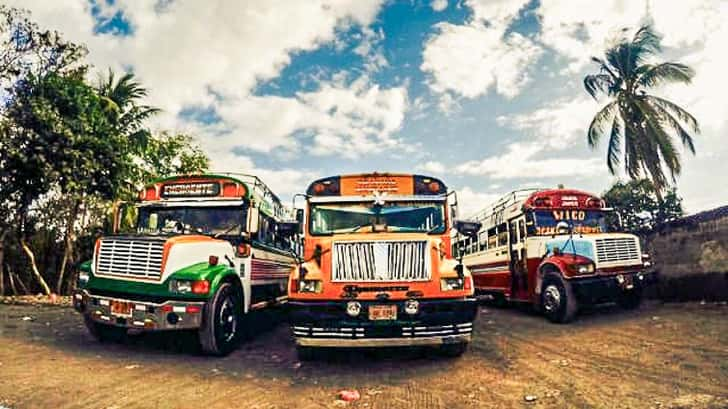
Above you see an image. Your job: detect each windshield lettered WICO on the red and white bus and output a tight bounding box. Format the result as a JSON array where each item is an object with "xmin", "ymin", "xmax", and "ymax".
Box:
[{"xmin": 529, "ymin": 209, "xmax": 614, "ymax": 236}]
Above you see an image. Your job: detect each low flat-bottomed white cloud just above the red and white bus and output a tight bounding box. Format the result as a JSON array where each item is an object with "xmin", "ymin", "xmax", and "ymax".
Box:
[{"xmin": 455, "ymin": 142, "xmax": 604, "ymax": 179}]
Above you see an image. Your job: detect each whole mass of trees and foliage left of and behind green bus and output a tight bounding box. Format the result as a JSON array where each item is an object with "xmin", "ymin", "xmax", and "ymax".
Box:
[{"xmin": 0, "ymin": 5, "xmax": 209, "ymax": 292}]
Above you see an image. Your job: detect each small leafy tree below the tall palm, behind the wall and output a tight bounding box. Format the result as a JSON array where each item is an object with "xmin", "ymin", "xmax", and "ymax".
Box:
[{"xmin": 603, "ymin": 179, "xmax": 684, "ymax": 234}]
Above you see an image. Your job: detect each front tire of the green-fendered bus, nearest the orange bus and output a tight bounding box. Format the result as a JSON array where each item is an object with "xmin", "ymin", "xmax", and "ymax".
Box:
[{"xmin": 198, "ymin": 282, "xmax": 243, "ymax": 356}]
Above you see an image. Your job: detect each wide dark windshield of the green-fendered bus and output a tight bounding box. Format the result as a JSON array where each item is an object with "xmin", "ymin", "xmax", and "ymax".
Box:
[{"xmin": 137, "ymin": 206, "xmax": 245, "ymax": 236}]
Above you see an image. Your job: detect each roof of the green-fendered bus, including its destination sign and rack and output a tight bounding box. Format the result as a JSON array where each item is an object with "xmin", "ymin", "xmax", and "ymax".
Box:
[{"xmin": 139, "ymin": 173, "xmax": 291, "ymax": 219}]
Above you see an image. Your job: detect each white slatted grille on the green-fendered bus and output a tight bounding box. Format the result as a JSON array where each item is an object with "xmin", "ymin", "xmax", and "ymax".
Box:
[{"xmin": 96, "ymin": 239, "xmax": 164, "ymax": 280}]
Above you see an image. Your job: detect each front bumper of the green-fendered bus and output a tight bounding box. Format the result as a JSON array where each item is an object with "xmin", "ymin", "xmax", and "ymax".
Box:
[{"xmin": 73, "ymin": 290, "xmax": 205, "ymax": 331}]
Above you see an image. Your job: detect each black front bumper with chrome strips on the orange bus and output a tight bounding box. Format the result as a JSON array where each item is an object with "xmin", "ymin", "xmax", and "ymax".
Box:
[{"xmin": 288, "ymin": 298, "xmax": 478, "ymax": 347}]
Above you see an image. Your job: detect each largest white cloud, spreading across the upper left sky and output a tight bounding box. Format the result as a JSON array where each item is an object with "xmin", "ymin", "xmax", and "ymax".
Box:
[{"xmin": 10, "ymin": 0, "xmax": 408, "ymax": 183}]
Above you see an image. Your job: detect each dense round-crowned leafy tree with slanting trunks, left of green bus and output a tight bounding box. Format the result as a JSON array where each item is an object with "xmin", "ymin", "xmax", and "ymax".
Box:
[{"xmin": 4, "ymin": 73, "xmax": 129, "ymax": 292}]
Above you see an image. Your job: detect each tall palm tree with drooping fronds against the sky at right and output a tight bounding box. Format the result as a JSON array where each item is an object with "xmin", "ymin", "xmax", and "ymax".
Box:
[{"xmin": 584, "ymin": 25, "xmax": 700, "ymax": 194}]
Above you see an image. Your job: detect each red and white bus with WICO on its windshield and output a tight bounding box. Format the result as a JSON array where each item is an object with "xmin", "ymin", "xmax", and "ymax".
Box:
[{"xmin": 455, "ymin": 189, "xmax": 652, "ymax": 322}]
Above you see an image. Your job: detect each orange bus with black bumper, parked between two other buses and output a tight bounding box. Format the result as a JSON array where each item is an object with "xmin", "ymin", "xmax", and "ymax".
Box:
[{"xmin": 288, "ymin": 173, "xmax": 479, "ymax": 359}]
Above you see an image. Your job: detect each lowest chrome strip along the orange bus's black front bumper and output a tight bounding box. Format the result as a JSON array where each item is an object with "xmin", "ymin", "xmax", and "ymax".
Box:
[{"xmin": 296, "ymin": 334, "xmax": 471, "ymax": 348}]
